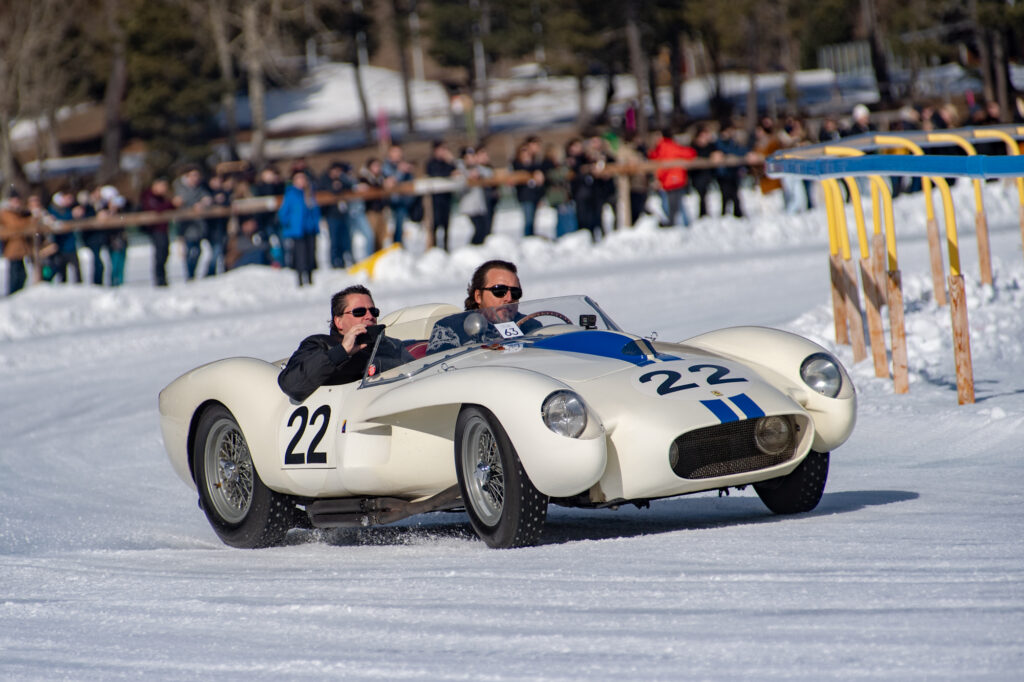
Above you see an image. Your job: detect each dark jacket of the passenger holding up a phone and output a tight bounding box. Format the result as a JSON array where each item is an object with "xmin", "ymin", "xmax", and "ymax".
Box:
[{"xmin": 278, "ymin": 332, "xmax": 414, "ymax": 402}]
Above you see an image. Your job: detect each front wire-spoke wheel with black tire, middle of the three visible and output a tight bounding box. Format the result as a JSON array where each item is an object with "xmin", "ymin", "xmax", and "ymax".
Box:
[{"xmin": 455, "ymin": 406, "xmax": 548, "ymax": 549}]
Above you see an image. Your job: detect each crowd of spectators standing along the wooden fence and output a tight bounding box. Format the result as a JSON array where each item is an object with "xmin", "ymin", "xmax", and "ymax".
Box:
[{"xmin": 0, "ymin": 96, "xmax": 1019, "ymax": 293}]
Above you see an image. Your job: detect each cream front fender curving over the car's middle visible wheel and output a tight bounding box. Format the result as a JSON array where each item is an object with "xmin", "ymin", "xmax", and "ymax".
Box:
[{"xmin": 361, "ymin": 367, "xmax": 607, "ymax": 497}]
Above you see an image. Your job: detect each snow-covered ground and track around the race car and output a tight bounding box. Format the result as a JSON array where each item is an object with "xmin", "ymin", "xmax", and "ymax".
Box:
[{"xmin": 0, "ymin": 174, "xmax": 1024, "ymax": 680}]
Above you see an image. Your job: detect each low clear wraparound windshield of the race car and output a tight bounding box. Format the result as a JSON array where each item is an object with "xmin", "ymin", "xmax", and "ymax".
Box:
[{"xmin": 362, "ymin": 296, "xmax": 622, "ymax": 386}]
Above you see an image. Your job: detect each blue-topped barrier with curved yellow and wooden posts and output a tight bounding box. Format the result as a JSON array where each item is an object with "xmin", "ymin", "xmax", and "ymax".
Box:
[{"xmin": 765, "ymin": 126, "xmax": 1024, "ymax": 404}]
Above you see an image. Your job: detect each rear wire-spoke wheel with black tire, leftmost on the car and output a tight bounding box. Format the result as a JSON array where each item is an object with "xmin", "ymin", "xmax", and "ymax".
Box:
[{"xmin": 193, "ymin": 404, "xmax": 295, "ymax": 549}]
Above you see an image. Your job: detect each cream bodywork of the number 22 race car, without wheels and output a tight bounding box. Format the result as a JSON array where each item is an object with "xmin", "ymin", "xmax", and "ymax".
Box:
[{"xmin": 160, "ymin": 296, "xmax": 856, "ymax": 546}]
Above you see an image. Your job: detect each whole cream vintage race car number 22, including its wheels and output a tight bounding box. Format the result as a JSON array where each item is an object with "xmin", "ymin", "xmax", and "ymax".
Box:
[{"xmin": 160, "ymin": 296, "xmax": 856, "ymax": 548}]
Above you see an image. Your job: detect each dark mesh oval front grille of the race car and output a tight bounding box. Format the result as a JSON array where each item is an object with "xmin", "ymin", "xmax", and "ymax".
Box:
[{"xmin": 672, "ymin": 419, "xmax": 799, "ymax": 478}]
